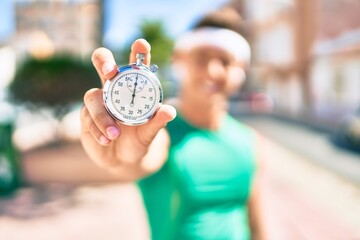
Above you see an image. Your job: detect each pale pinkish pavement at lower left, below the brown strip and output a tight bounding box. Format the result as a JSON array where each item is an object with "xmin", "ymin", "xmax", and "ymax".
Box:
[{"xmin": 0, "ymin": 183, "xmax": 149, "ymax": 240}]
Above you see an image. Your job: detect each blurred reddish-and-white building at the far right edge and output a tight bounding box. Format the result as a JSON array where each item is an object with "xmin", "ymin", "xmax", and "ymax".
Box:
[{"xmin": 309, "ymin": 0, "xmax": 360, "ymax": 122}]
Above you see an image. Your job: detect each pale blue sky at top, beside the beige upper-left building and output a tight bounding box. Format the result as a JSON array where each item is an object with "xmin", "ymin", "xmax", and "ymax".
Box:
[{"xmin": 0, "ymin": 0, "xmax": 227, "ymax": 48}]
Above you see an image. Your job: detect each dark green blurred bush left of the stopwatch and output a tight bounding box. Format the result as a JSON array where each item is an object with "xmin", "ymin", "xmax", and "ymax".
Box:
[{"xmin": 10, "ymin": 56, "xmax": 100, "ymax": 114}]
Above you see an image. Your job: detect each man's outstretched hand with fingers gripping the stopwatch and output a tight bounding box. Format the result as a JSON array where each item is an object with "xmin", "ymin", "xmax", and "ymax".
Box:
[{"xmin": 81, "ymin": 39, "xmax": 176, "ymax": 180}]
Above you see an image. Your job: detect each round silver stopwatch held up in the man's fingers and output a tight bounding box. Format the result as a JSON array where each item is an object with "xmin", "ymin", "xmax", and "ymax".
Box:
[{"xmin": 103, "ymin": 53, "xmax": 163, "ymax": 126}]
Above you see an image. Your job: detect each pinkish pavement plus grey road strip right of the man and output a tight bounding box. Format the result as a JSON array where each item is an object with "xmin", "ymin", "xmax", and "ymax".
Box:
[{"xmin": 239, "ymin": 116, "xmax": 360, "ymax": 239}]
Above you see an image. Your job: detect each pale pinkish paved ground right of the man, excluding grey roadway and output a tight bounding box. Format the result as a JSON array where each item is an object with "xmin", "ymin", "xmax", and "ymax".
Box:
[{"xmin": 262, "ymin": 132, "xmax": 360, "ymax": 240}]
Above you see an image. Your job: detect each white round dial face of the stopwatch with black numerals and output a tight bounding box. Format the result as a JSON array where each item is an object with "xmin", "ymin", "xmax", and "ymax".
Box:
[{"xmin": 110, "ymin": 72, "xmax": 160, "ymax": 121}]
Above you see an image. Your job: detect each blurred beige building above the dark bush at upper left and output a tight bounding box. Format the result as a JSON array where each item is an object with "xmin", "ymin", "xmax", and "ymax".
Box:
[{"xmin": 12, "ymin": 0, "xmax": 102, "ymax": 58}]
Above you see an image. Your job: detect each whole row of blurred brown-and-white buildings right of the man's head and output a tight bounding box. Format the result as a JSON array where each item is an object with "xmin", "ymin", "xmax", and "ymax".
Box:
[{"xmin": 238, "ymin": 0, "xmax": 360, "ymax": 125}]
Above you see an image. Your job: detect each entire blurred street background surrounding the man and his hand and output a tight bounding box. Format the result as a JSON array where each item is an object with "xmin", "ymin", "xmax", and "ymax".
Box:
[{"xmin": 0, "ymin": 0, "xmax": 360, "ymax": 240}]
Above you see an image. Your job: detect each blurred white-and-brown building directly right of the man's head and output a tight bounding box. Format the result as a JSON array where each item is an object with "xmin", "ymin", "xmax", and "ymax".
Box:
[{"xmin": 245, "ymin": 0, "xmax": 314, "ymax": 114}]
